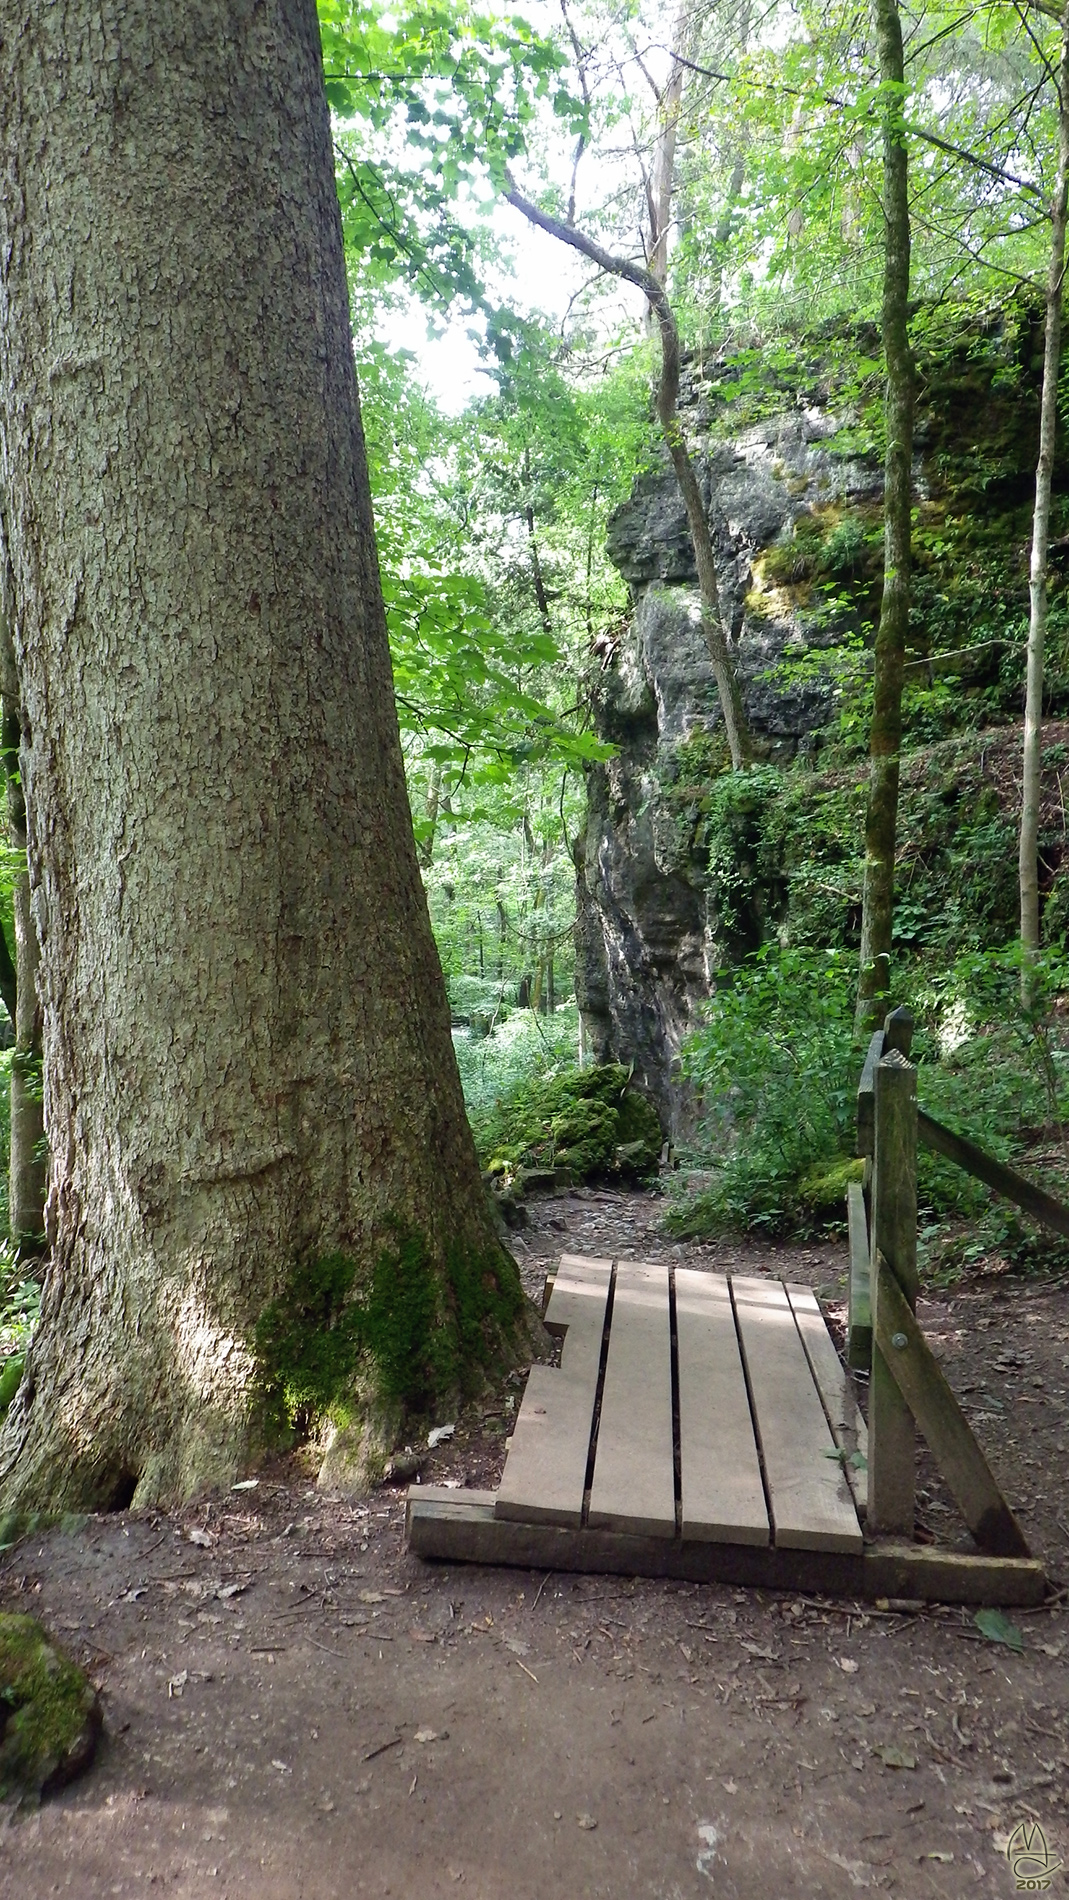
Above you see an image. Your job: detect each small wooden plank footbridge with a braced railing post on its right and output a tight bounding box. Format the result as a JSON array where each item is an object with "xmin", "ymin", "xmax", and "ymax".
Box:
[{"xmin": 408, "ymin": 1011, "xmax": 1069, "ymax": 1604}]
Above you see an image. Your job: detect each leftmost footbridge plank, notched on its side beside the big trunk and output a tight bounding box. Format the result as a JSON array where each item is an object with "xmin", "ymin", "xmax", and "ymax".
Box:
[{"xmin": 496, "ymin": 1254, "xmax": 611, "ymax": 1526}]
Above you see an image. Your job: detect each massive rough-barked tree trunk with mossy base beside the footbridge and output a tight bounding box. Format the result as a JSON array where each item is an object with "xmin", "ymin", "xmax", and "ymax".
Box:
[{"xmin": 0, "ymin": 0, "xmax": 524, "ymax": 1509}]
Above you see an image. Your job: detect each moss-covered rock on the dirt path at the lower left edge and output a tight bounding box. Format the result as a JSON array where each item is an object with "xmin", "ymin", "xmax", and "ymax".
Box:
[{"xmin": 0, "ymin": 1615, "xmax": 103, "ymax": 1803}]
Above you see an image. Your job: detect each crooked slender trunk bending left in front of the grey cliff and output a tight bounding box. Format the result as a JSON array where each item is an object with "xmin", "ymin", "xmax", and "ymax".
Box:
[{"xmin": 505, "ymin": 181, "xmax": 752, "ymax": 771}]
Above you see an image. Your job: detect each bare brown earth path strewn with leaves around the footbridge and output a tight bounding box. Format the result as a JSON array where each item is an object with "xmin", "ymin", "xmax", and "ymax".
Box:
[{"xmin": 0, "ymin": 1193, "xmax": 1069, "ymax": 1900}]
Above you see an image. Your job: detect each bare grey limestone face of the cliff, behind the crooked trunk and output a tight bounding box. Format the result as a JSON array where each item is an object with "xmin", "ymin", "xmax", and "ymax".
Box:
[{"xmin": 575, "ymin": 382, "xmax": 881, "ymax": 1132}]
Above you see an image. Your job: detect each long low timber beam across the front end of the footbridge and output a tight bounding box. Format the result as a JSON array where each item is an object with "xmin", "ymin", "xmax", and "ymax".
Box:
[{"xmin": 406, "ymin": 1486, "xmax": 1044, "ymax": 1607}]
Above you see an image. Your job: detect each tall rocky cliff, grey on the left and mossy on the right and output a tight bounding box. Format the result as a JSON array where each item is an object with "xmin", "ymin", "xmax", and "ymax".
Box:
[{"xmin": 575, "ymin": 321, "xmax": 1065, "ymax": 1132}]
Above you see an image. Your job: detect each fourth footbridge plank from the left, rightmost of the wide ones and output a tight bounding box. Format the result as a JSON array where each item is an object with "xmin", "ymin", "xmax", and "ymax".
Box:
[{"xmin": 731, "ymin": 1275, "xmax": 862, "ymax": 1550}]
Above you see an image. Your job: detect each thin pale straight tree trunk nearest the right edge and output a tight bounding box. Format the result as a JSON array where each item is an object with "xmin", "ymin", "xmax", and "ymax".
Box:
[{"xmin": 1020, "ymin": 6, "xmax": 1069, "ymax": 1007}]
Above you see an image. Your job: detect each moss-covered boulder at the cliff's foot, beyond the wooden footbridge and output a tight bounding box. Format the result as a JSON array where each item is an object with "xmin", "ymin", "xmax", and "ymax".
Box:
[{"xmin": 475, "ymin": 1062, "xmax": 663, "ymax": 1180}]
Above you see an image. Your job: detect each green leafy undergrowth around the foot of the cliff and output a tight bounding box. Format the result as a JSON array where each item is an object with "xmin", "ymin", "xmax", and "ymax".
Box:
[{"xmin": 450, "ymin": 726, "xmax": 1069, "ymax": 1284}]
